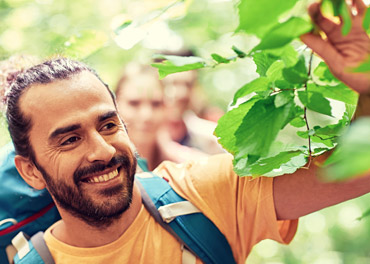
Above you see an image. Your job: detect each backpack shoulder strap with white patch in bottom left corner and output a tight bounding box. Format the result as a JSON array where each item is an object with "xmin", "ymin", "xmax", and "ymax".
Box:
[{"xmin": 12, "ymin": 232, "xmax": 55, "ymax": 264}]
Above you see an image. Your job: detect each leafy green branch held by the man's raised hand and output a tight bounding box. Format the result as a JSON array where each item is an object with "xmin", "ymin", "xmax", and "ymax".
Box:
[{"xmin": 153, "ymin": 0, "xmax": 370, "ymax": 177}]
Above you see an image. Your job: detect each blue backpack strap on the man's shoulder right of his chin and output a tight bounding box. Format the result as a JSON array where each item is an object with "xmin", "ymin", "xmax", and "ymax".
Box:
[{"xmin": 136, "ymin": 173, "xmax": 236, "ymax": 264}]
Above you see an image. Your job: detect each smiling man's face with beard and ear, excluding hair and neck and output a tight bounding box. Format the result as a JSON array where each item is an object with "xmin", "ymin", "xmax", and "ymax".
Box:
[{"xmin": 15, "ymin": 72, "xmax": 136, "ymax": 229}]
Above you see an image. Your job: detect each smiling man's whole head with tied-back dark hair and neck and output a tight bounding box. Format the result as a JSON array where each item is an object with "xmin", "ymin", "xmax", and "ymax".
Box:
[{"xmin": 8, "ymin": 64, "xmax": 141, "ymax": 248}]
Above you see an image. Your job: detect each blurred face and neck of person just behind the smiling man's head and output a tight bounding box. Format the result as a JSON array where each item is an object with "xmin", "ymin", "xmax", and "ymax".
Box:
[{"xmin": 116, "ymin": 63, "xmax": 206, "ymax": 170}]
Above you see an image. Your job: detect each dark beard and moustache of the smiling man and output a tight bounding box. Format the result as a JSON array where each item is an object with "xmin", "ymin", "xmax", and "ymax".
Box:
[{"xmin": 37, "ymin": 156, "xmax": 137, "ymax": 228}]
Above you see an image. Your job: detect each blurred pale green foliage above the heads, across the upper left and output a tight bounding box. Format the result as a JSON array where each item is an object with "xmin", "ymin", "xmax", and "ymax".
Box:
[{"xmin": 0, "ymin": 0, "xmax": 254, "ymax": 146}]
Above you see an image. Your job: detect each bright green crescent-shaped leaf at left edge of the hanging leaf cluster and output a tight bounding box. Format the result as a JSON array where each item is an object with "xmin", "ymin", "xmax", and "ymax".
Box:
[{"xmin": 214, "ymin": 97, "xmax": 259, "ymax": 154}]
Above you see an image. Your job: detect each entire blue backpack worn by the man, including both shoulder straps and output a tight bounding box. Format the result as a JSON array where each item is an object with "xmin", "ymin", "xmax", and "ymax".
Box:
[{"xmin": 0, "ymin": 144, "xmax": 236, "ymax": 264}]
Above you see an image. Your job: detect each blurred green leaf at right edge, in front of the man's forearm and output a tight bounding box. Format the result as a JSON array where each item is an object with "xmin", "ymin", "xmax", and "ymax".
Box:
[{"xmin": 323, "ymin": 118, "xmax": 370, "ymax": 180}]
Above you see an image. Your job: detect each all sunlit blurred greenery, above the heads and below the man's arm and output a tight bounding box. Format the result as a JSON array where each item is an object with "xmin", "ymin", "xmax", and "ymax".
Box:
[{"xmin": 0, "ymin": 0, "xmax": 370, "ymax": 264}]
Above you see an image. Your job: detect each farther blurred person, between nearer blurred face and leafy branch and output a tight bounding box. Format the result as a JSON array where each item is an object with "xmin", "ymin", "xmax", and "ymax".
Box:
[{"xmin": 157, "ymin": 50, "xmax": 224, "ymax": 154}]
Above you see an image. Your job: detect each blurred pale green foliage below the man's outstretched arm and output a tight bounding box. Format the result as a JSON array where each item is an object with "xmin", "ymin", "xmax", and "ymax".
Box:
[{"xmin": 247, "ymin": 195, "xmax": 370, "ymax": 264}]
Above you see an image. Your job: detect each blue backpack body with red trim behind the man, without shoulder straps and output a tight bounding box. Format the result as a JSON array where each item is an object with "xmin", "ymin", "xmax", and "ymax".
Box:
[{"xmin": 0, "ymin": 144, "xmax": 60, "ymax": 263}]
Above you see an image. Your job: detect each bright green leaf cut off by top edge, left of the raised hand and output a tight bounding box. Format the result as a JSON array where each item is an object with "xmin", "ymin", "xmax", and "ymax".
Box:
[{"xmin": 236, "ymin": 0, "xmax": 297, "ymax": 37}]
